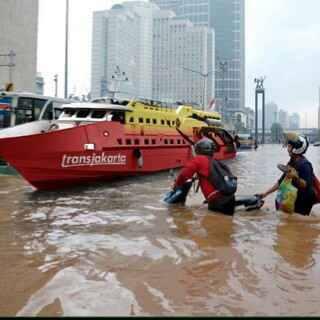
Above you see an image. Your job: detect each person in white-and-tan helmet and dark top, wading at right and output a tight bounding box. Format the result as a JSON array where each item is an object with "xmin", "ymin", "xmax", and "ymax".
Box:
[{"xmin": 260, "ymin": 133, "xmax": 315, "ymax": 215}]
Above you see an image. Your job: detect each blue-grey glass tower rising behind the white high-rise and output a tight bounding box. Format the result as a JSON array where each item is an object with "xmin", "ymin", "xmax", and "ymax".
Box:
[{"xmin": 151, "ymin": 0, "xmax": 245, "ymax": 116}]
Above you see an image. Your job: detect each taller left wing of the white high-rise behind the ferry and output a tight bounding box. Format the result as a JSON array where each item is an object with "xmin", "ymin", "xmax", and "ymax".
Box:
[{"xmin": 91, "ymin": 2, "xmax": 159, "ymax": 99}]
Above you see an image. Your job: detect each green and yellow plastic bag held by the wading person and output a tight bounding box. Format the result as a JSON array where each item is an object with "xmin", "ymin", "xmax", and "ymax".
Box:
[{"xmin": 276, "ymin": 178, "xmax": 298, "ymax": 213}]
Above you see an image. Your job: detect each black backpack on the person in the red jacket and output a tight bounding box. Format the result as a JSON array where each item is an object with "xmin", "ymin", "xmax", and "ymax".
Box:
[{"xmin": 208, "ymin": 159, "xmax": 237, "ymax": 196}]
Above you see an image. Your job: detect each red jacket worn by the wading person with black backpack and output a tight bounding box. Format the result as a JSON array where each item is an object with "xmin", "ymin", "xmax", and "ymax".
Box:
[{"xmin": 175, "ymin": 155, "xmax": 220, "ymax": 200}]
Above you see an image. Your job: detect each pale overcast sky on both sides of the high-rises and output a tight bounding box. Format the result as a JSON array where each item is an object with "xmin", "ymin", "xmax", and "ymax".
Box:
[{"xmin": 38, "ymin": 0, "xmax": 320, "ymax": 127}]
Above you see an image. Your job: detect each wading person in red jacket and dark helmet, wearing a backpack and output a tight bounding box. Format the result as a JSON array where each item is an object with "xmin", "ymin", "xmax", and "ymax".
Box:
[{"xmin": 170, "ymin": 138, "xmax": 263, "ymax": 215}]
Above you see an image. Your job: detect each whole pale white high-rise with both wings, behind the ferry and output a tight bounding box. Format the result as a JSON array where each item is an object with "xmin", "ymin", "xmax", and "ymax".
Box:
[{"xmin": 91, "ymin": 2, "xmax": 214, "ymax": 105}]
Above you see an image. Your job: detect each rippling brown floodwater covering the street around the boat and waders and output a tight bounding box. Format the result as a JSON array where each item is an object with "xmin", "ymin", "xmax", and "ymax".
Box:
[{"xmin": 0, "ymin": 146, "xmax": 320, "ymax": 316}]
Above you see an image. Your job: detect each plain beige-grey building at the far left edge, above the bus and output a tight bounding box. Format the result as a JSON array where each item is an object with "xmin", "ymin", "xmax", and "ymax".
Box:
[{"xmin": 0, "ymin": 0, "xmax": 38, "ymax": 92}]
